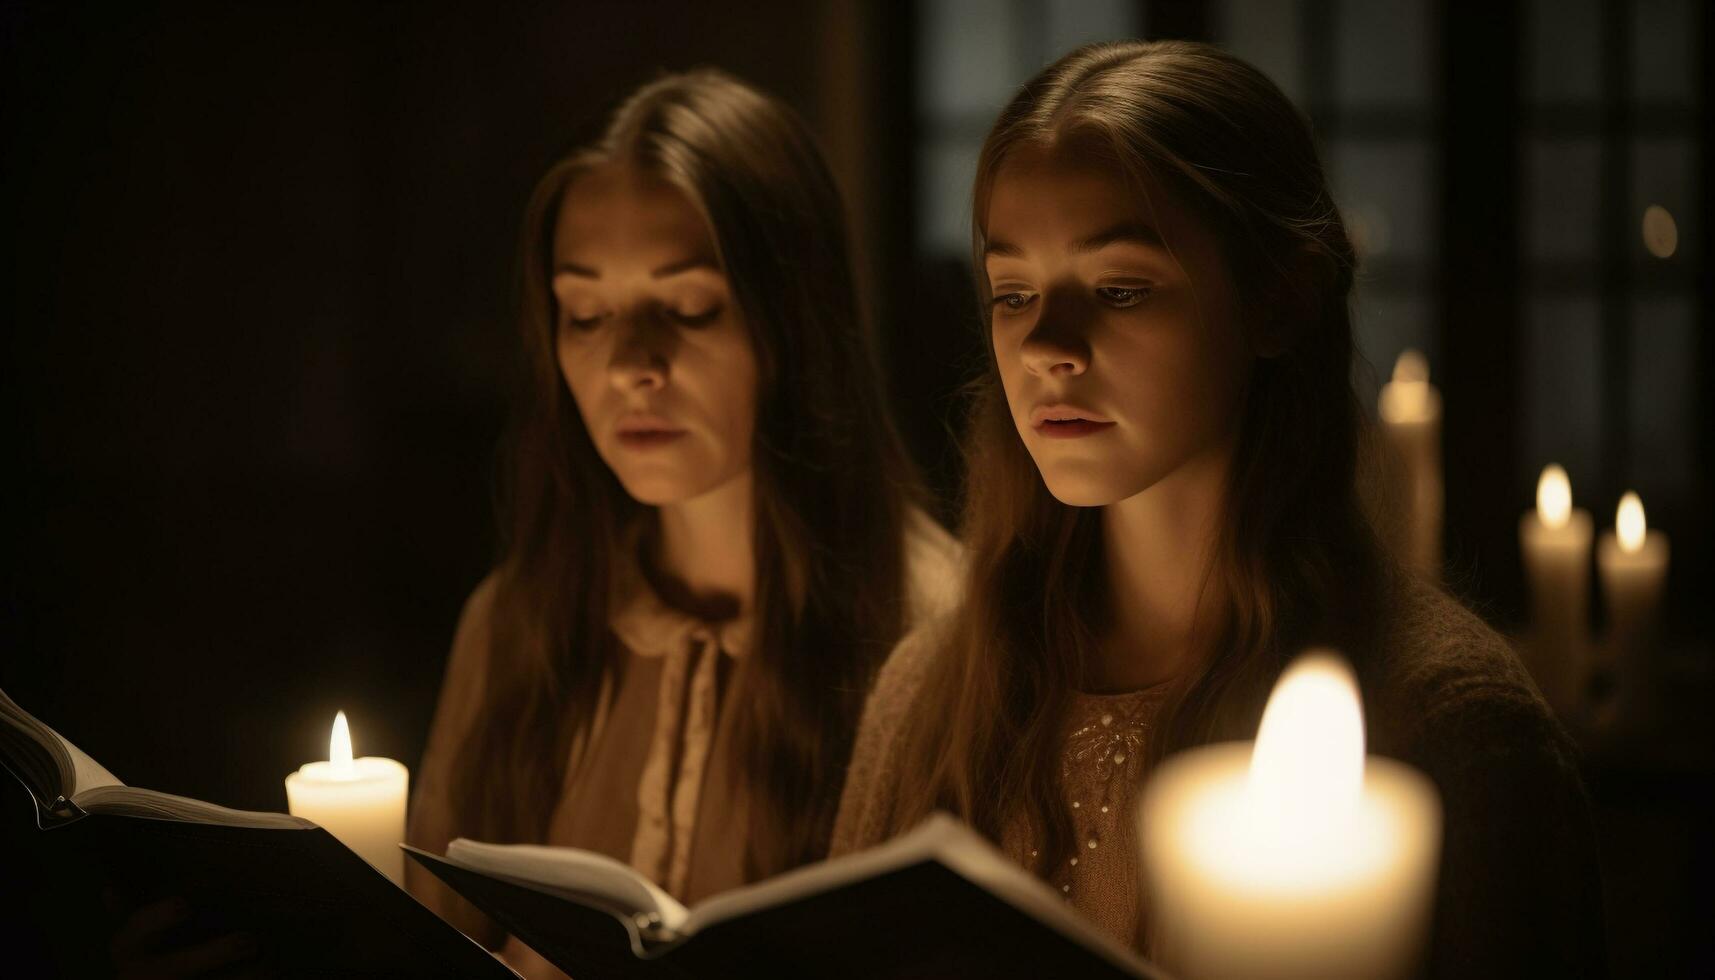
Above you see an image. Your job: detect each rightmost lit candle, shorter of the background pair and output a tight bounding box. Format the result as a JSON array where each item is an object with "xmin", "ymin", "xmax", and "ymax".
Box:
[{"xmin": 1597, "ymin": 493, "xmax": 1669, "ymax": 710}]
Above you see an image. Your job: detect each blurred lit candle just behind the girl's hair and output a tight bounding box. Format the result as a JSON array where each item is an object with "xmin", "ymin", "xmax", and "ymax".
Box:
[{"xmin": 1375, "ymin": 350, "xmax": 1446, "ymax": 578}]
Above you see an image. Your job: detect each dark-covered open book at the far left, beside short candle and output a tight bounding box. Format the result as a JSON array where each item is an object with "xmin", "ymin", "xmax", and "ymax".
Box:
[{"xmin": 0, "ymin": 692, "xmax": 513, "ymax": 977}]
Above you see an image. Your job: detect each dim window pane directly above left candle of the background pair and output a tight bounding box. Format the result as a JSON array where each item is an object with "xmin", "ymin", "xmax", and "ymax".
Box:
[{"xmin": 1518, "ymin": 292, "xmax": 1602, "ymax": 490}]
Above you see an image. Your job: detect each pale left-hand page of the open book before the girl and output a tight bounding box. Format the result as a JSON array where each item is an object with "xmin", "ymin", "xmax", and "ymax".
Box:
[{"xmin": 446, "ymin": 838, "xmax": 686, "ymax": 932}]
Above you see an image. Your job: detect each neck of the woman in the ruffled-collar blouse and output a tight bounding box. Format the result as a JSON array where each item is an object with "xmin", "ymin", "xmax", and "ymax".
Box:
[{"xmin": 652, "ymin": 470, "xmax": 756, "ymax": 614}]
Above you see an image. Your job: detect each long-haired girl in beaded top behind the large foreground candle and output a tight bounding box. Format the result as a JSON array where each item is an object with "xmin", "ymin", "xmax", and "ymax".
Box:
[{"xmin": 833, "ymin": 41, "xmax": 1604, "ymax": 975}]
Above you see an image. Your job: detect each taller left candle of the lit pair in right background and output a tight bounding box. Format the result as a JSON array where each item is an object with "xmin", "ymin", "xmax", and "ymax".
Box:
[{"xmin": 1518, "ymin": 463, "xmax": 1592, "ymax": 716}]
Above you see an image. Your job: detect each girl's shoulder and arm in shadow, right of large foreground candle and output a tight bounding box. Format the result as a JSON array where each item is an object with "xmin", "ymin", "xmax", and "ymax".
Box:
[{"xmin": 1363, "ymin": 582, "xmax": 1605, "ymax": 977}]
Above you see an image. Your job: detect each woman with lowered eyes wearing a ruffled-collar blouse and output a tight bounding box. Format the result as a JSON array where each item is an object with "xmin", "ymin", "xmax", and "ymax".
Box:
[{"xmin": 408, "ymin": 72, "xmax": 955, "ymax": 973}]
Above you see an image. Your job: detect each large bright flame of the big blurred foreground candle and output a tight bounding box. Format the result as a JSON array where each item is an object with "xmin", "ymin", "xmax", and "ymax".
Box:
[{"xmin": 1250, "ymin": 650, "xmax": 1363, "ymax": 827}]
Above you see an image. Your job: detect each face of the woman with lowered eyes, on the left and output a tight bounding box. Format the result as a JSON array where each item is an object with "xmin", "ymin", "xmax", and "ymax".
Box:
[{"xmin": 552, "ymin": 165, "xmax": 756, "ymax": 505}]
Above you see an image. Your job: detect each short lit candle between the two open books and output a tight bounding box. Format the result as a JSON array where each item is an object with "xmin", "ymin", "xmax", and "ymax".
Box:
[{"xmin": 286, "ymin": 711, "xmax": 410, "ymax": 886}]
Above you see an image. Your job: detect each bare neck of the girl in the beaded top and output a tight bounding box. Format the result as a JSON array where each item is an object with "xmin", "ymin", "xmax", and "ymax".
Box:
[{"xmin": 1084, "ymin": 446, "xmax": 1231, "ymax": 692}]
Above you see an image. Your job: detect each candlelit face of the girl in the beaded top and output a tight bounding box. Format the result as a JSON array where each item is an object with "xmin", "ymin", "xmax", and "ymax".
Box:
[{"xmin": 984, "ymin": 148, "xmax": 1252, "ymax": 506}]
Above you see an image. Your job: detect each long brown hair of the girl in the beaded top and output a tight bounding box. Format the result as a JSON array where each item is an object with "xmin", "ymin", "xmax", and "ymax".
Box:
[{"xmin": 899, "ymin": 41, "xmax": 1387, "ymax": 868}]
